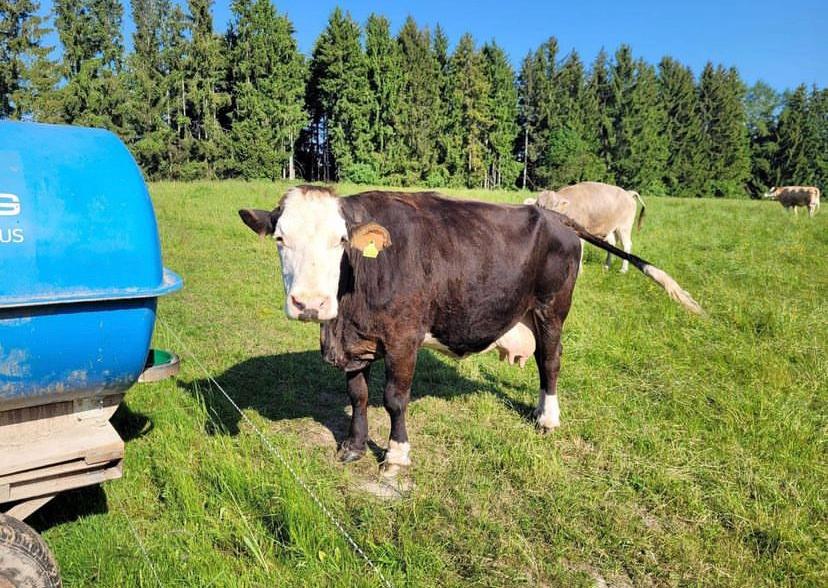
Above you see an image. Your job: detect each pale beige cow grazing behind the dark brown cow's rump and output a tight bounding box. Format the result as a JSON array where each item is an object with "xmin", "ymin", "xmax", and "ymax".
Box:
[{"xmin": 524, "ymin": 182, "xmax": 645, "ymax": 272}]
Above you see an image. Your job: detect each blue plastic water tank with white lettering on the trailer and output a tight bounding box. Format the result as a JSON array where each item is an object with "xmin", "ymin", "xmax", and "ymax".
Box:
[{"xmin": 0, "ymin": 122, "xmax": 181, "ymax": 410}]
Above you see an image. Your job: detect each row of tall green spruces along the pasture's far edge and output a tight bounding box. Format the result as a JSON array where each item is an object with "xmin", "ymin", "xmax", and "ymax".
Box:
[{"xmin": 0, "ymin": 0, "xmax": 828, "ymax": 196}]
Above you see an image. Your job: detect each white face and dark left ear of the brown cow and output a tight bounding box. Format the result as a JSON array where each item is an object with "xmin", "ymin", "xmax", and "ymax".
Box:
[{"xmin": 239, "ymin": 188, "xmax": 348, "ymax": 321}]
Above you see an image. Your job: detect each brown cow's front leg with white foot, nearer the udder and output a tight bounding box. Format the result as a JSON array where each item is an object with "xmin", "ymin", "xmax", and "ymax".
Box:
[{"xmin": 380, "ymin": 344, "xmax": 417, "ymax": 476}]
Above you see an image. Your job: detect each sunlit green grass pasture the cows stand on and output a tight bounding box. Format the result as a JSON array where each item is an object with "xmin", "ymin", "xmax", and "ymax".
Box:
[{"xmin": 33, "ymin": 182, "xmax": 828, "ymax": 587}]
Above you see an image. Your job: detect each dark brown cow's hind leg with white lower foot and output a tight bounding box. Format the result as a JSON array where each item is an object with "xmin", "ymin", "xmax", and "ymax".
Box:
[{"xmin": 533, "ymin": 275, "xmax": 575, "ymax": 432}]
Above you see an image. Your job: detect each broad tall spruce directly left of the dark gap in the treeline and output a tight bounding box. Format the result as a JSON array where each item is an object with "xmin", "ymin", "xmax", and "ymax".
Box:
[{"xmin": 227, "ymin": 0, "xmax": 306, "ymax": 179}]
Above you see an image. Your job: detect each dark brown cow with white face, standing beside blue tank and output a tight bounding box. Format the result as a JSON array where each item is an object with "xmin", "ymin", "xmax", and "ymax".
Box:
[{"xmin": 239, "ymin": 186, "xmax": 701, "ymax": 473}]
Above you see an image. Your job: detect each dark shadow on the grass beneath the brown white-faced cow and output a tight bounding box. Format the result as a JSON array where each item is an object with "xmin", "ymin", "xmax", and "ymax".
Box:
[{"xmin": 178, "ymin": 351, "xmax": 535, "ymax": 456}]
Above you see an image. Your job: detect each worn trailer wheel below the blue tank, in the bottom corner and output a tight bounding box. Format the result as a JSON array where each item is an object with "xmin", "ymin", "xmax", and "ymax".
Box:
[{"xmin": 0, "ymin": 513, "xmax": 61, "ymax": 588}]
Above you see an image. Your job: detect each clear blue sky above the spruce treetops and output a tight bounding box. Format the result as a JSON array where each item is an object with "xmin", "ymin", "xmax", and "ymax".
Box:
[{"xmin": 42, "ymin": 0, "xmax": 828, "ymax": 90}]
